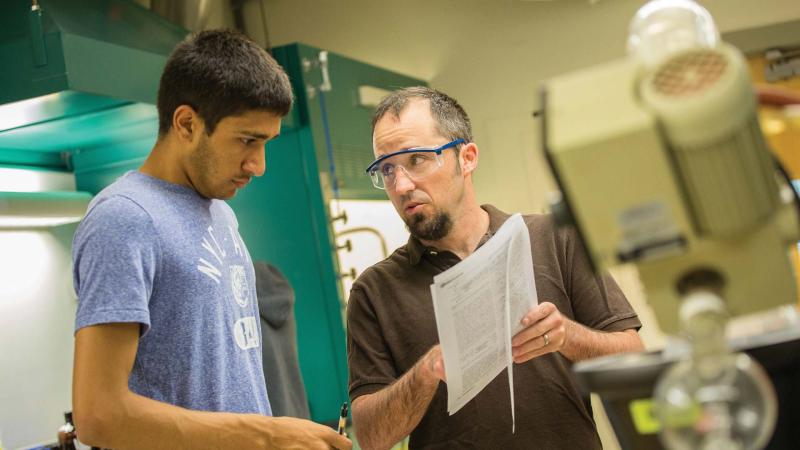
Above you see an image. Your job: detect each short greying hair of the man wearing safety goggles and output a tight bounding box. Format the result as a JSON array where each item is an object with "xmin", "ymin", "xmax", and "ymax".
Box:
[{"xmin": 372, "ymin": 86, "xmax": 472, "ymax": 142}]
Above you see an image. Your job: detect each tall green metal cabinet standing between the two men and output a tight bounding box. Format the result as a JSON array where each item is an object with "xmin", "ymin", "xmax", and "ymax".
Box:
[{"xmin": 229, "ymin": 44, "xmax": 424, "ymax": 422}]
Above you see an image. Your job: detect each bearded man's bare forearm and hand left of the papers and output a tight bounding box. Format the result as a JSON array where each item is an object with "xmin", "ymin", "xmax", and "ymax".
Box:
[{"xmin": 353, "ymin": 345, "xmax": 445, "ymax": 450}]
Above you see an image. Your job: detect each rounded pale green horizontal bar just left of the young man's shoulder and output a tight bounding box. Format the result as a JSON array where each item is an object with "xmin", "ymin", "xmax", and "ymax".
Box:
[{"xmin": 0, "ymin": 191, "xmax": 92, "ymax": 230}]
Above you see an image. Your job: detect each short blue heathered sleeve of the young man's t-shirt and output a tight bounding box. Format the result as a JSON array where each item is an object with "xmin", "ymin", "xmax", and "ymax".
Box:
[{"xmin": 72, "ymin": 197, "xmax": 160, "ymax": 335}]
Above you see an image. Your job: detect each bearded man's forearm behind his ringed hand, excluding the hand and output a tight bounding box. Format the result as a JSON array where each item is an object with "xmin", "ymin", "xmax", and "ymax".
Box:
[{"xmin": 560, "ymin": 320, "xmax": 644, "ymax": 361}]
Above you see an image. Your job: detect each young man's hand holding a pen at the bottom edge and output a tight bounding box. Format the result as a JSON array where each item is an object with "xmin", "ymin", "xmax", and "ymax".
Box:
[{"xmin": 267, "ymin": 417, "xmax": 353, "ymax": 450}]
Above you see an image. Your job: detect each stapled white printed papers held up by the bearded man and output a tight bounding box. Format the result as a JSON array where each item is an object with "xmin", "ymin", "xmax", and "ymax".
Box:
[{"xmin": 431, "ymin": 214, "xmax": 538, "ymax": 432}]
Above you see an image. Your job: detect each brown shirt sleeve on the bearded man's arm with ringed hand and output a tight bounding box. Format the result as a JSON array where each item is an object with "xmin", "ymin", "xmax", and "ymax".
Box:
[{"xmin": 565, "ymin": 227, "xmax": 642, "ymax": 331}]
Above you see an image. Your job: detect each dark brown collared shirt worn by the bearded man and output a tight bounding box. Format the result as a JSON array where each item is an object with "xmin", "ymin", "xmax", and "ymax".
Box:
[{"xmin": 347, "ymin": 205, "xmax": 641, "ymax": 450}]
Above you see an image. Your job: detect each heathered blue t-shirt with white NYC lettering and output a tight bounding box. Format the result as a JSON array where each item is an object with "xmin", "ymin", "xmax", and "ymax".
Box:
[{"xmin": 72, "ymin": 171, "xmax": 272, "ymax": 415}]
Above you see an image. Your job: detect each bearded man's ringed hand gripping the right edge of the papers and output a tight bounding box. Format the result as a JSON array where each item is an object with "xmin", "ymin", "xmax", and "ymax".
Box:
[{"xmin": 511, "ymin": 302, "xmax": 569, "ymax": 364}]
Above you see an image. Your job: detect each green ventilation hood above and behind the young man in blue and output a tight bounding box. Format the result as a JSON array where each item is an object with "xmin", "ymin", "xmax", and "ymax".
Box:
[{"xmin": 0, "ymin": 0, "xmax": 188, "ymax": 170}]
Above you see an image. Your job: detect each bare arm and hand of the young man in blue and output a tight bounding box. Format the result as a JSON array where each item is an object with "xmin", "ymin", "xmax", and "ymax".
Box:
[{"xmin": 72, "ymin": 323, "xmax": 351, "ymax": 450}]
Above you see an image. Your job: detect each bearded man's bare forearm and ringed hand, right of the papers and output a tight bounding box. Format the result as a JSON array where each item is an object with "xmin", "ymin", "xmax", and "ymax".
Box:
[{"xmin": 511, "ymin": 302, "xmax": 644, "ymax": 364}]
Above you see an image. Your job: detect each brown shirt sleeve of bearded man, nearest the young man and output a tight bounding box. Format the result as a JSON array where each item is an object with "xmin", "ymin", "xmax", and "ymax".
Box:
[{"xmin": 347, "ymin": 287, "xmax": 399, "ymax": 402}]
